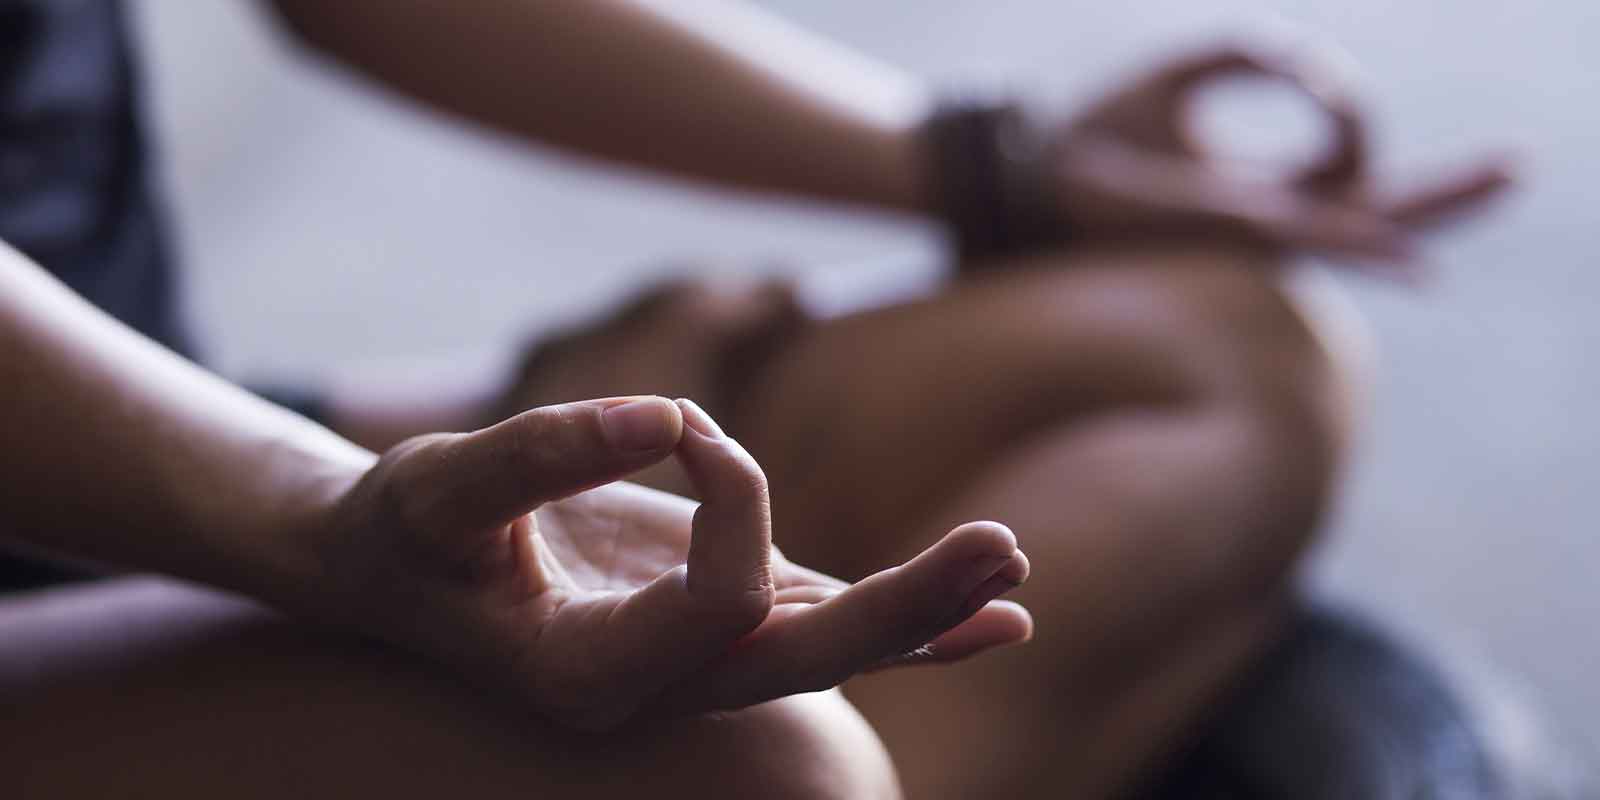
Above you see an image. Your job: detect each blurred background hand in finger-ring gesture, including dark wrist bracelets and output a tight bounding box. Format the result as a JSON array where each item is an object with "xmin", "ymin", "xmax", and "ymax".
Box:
[{"xmin": 928, "ymin": 46, "xmax": 1510, "ymax": 278}]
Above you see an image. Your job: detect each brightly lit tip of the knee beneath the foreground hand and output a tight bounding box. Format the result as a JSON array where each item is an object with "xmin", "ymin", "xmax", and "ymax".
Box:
[{"xmin": 693, "ymin": 690, "xmax": 899, "ymax": 800}]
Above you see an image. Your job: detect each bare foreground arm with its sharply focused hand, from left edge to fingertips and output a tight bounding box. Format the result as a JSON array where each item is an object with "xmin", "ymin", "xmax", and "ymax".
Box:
[{"xmin": 0, "ymin": 246, "xmax": 1030, "ymax": 728}]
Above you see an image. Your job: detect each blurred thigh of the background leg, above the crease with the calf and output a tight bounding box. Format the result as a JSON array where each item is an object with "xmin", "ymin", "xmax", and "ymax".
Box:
[{"xmin": 731, "ymin": 240, "xmax": 1344, "ymax": 578}]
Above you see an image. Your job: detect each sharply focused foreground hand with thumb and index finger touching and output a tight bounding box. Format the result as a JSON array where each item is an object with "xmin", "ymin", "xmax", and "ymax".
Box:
[{"xmin": 318, "ymin": 397, "xmax": 1032, "ymax": 730}]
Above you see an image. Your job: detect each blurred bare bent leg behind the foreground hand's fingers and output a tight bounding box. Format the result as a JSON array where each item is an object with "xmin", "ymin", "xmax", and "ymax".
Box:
[{"xmin": 733, "ymin": 251, "xmax": 1347, "ymax": 797}]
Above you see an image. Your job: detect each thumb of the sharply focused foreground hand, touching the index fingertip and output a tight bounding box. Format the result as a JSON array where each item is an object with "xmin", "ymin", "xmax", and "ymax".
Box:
[{"xmin": 408, "ymin": 397, "xmax": 683, "ymax": 531}]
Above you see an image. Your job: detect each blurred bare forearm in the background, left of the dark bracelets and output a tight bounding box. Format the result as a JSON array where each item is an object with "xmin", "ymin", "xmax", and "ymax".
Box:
[{"xmin": 275, "ymin": 0, "xmax": 928, "ymax": 211}]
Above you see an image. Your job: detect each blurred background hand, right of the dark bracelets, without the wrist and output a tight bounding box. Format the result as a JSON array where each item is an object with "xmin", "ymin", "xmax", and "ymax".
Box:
[{"xmin": 1045, "ymin": 48, "xmax": 1510, "ymax": 278}]
